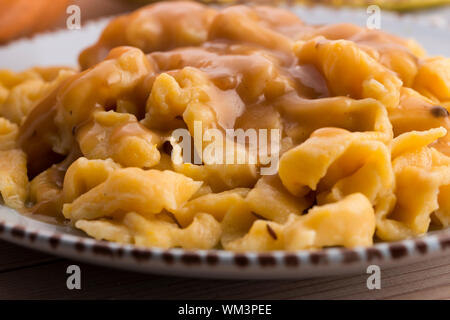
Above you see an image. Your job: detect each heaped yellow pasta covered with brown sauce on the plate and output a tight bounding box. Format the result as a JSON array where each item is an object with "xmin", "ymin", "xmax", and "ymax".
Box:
[{"xmin": 0, "ymin": 2, "xmax": 450, "ymax": 251}]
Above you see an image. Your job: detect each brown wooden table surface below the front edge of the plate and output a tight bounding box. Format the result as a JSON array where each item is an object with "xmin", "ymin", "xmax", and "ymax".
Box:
[{"xmin": 0, "ymin": 240, "xmax": 450, "ymax": 299}]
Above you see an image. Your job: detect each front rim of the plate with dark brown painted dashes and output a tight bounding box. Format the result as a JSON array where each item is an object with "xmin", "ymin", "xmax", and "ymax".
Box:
[{"xmin": 0, "ymin": 212, "xmax": 450, "ymax": 279}]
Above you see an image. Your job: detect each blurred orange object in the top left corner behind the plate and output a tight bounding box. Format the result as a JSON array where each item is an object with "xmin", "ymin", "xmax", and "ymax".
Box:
[{"xmin": 0, "ymin": 0, "xmax": 69, "ymax": 43}]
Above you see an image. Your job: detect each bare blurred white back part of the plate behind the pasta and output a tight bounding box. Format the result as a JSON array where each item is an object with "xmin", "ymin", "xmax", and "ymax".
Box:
[{"xmin": 0, "ymin": 6, "xmax": 450, "ymax": 71}]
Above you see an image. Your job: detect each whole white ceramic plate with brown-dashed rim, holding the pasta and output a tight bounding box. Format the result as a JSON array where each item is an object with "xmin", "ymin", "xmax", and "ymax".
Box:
[{"xmin": 0, "ymin": 3, "xmax": 450, "ymax": 279}]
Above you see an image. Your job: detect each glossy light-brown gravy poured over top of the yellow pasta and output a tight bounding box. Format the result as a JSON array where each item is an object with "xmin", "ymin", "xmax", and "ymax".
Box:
[{"xmin": 14, "ymin": 2, "xmax": 428, "ymax": 216}]
